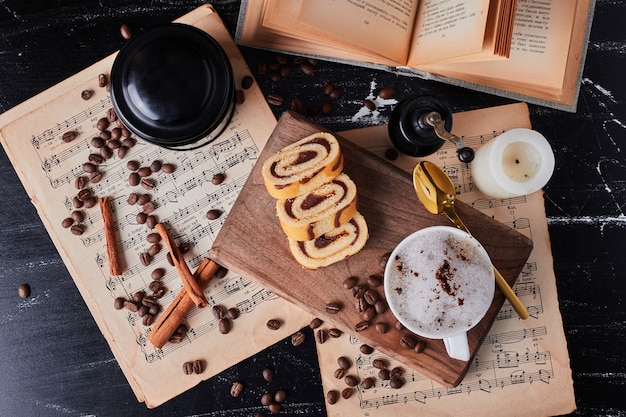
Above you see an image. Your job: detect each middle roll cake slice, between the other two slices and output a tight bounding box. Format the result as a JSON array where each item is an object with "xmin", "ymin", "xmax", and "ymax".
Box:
[{"xmin": 276, "ymin": 173, "xmax": 357, "ymax": 241}]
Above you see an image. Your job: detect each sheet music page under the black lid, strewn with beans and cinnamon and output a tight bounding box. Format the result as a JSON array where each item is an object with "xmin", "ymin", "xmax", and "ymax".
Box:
[{"xmin": 0, "ymin": 6, "xmax": 311, "ymax": 407}]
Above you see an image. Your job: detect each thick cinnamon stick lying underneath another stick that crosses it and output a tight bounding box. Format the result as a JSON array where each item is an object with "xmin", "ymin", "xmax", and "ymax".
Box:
[{"xmin": 148, "ymin": 258, "xmax": 219, "ymax": 349}]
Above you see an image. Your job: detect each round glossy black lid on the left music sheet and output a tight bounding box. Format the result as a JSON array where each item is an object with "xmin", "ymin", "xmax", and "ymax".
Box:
[{"xmin": 111, "ymin": 23, "xmax": 234, "ymax": 149}]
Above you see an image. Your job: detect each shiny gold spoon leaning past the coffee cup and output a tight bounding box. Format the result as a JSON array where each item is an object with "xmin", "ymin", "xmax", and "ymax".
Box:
[{"xmin": 413, "ymin": 161, "xmax": 528, "ymax": 319}]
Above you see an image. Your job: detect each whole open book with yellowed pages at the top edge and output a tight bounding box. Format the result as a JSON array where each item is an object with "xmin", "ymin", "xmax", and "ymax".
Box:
[{"xmin": 236, "ymin": 0, "xmax": 595, "ymax": 111}]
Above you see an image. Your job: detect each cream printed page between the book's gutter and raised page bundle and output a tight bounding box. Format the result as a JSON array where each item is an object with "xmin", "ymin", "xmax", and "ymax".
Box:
[{"xmin": 408, "ymin": 0, "xmax": 490, "ymax": 65}]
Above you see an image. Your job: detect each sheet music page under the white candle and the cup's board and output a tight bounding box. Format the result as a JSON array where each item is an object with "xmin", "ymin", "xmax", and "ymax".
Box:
[{"xmin": 317, "ymin": 104, "xmax": 576, "ymax": 417}]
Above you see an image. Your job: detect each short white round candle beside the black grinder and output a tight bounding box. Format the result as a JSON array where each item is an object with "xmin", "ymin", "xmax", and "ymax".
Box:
[{"xmin": 470, "ymin": 128, "xmax": 554, "ymax": 198}]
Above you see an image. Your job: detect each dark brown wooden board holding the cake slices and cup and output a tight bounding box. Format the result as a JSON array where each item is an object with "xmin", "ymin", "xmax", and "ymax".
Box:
[{"xmin": 211, "ymin": 112, "xmax": 532, "ymax": 387}]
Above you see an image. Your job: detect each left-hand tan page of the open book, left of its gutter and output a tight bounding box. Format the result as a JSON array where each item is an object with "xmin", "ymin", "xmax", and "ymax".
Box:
[{"xmin": 298, "ymin": 0, "xmax": 419, "ymax": 62}]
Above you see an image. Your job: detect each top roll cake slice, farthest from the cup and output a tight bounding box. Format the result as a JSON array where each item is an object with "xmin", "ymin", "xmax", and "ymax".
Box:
[{"xmin": 261, "ymin": 132, "xmax": 343, "ymax": 199}]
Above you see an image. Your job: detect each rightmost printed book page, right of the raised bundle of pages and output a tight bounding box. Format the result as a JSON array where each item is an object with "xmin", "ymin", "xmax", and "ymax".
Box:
[{"xmin": 416, "ymin": 0, "xmax": 576, "ymax": 95}]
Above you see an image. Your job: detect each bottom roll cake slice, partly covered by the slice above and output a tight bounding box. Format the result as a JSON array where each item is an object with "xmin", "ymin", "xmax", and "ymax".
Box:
[{"xmin": 289, "ymin": 212, "xmax": 369, "ymax": 269}]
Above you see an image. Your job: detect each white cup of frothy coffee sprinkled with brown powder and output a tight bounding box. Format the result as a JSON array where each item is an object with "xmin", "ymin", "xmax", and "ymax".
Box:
[{"xmin": 384, "ymin": 226, "xmax": 495, "ymax": 361}]
